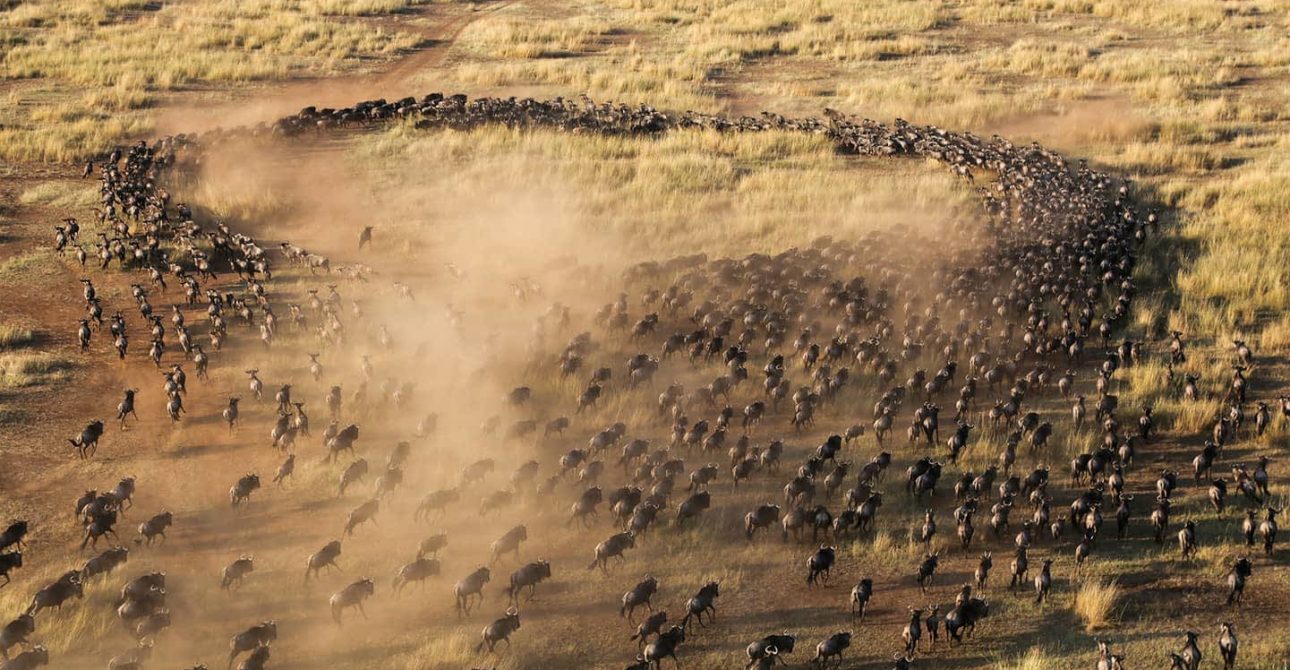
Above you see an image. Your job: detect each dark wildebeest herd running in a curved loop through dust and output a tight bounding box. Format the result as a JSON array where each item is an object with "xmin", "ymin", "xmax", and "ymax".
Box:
[{"xmin": 0, "ymin": 94, "xmax": 1290, "ymax": 670}]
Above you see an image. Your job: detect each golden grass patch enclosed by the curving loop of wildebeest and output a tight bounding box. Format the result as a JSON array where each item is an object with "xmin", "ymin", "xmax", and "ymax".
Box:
[{"xmin": 345, "ymin": 128, "xmax": 970, "ymax": 257}]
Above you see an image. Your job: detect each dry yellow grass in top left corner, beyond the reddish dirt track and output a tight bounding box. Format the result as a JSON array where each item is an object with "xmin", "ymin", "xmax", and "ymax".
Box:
[{"xmin": 0, "ymin": 0, "xmax": 418, "ymax": 161}]
